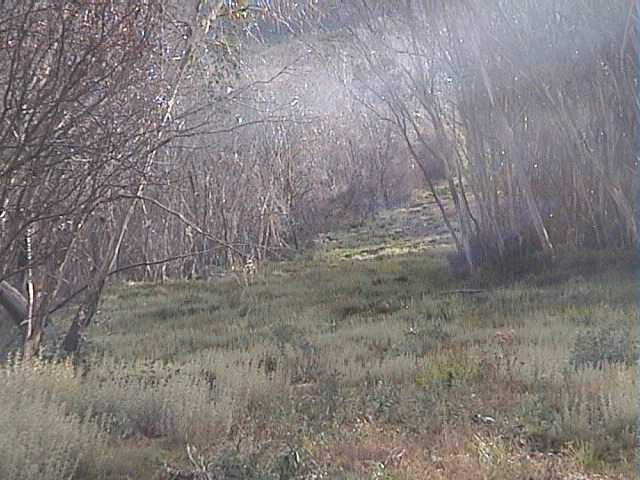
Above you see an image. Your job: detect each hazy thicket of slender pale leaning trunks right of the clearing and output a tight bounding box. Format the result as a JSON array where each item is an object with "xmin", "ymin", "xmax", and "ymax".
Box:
[{"xmin": 336, "ymin": 0, "xmax": 637, "ymax": 268}]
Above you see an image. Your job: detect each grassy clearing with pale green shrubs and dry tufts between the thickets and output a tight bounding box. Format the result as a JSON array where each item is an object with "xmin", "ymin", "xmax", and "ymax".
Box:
[{"xmin": 0, "ymin": 196, "xmax": 637, "ymax": 480}]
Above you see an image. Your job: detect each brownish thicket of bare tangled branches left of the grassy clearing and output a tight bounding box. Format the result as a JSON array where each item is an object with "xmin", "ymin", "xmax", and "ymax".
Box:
[{"xmin": 0, "ymin": 0, "xmax": 407, "ymax": 355}]
